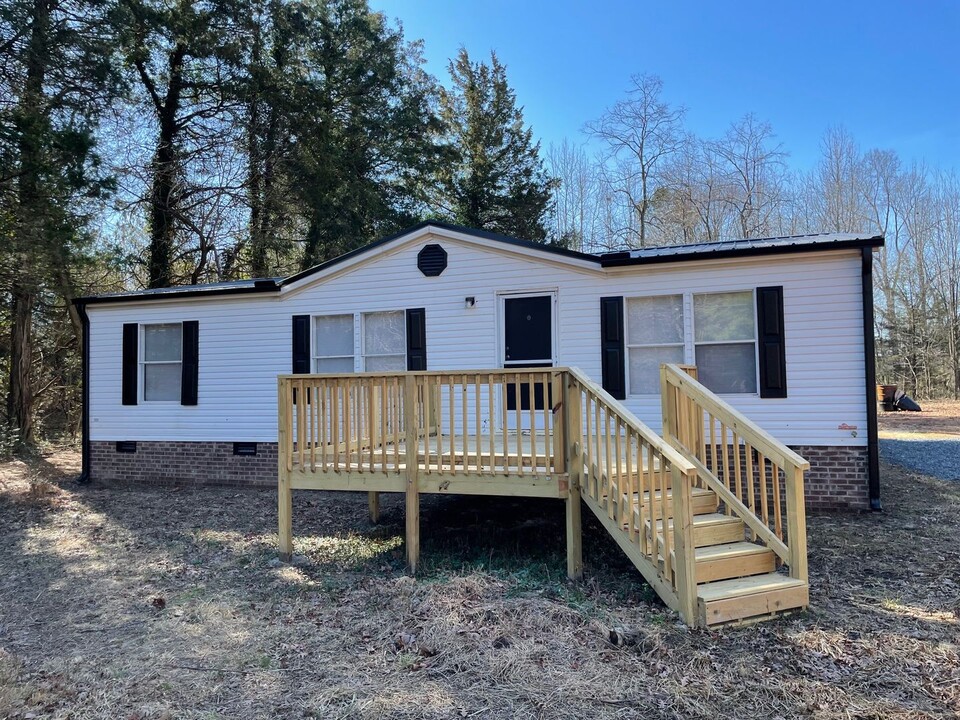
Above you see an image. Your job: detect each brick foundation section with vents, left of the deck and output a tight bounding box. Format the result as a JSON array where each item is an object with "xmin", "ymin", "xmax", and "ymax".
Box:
[{"xmin": 90, "ymin": 440, "xmax": 277, "ymax": 487}]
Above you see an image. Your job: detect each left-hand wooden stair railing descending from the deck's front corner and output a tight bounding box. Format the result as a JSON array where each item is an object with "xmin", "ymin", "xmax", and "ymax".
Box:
[{"xmin": 564, "ymin": 368, "xmax": 697, "ymax": 624}]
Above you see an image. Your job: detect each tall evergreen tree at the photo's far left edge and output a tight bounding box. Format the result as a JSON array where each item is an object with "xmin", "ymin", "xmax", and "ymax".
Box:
[{"xmin": 0, "ymin": 0, "xmax": 112, "ymax": 450}]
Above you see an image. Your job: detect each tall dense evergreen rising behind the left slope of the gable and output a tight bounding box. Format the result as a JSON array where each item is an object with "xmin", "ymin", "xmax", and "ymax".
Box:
[{"xmin": 290, "ymin": 0, "xmax": 442, "ymax": 267}]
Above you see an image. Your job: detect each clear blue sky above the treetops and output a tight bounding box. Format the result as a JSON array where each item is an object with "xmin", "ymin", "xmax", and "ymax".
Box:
[{"xmin": 370, "ymin": 0, "xmax": 960, "ymax": 171}]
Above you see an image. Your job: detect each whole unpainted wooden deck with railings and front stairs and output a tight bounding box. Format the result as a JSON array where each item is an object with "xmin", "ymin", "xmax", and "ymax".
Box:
[{"xmin": 278, "ymin": 365, "xmax": 809, "ymax": 626}]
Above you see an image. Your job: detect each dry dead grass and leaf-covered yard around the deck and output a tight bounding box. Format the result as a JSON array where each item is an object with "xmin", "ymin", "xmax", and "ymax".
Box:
[{"xmin": 0, "ymin": 453, "xmax": 960, "ymax": 720}]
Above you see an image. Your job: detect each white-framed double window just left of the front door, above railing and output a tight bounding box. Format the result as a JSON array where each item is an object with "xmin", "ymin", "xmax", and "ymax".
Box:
[{"xmin": 313, "ymin": 310, "xmax": 407, "ymax": 373}]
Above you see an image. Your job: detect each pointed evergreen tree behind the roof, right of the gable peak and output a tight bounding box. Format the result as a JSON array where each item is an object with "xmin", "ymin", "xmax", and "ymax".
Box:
[{"xmin": 435, "ymin": 48, "xmax": 555, "ymax": 242}]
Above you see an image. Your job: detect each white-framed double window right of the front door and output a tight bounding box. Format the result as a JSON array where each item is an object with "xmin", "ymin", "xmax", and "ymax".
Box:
[{"xmin": 624, "ymin": 289, "xmax": 759, "ymax": 395}]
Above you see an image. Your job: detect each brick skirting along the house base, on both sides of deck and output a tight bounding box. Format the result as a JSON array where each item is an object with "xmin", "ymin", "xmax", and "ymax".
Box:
[{"xmin": 90, "ymin": 441, "xmax": 870, "ymax": 510}]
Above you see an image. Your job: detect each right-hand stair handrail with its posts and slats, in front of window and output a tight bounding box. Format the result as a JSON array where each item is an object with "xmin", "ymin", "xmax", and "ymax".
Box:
[{"xmin": 660, "ymin": 363, "xmax": 810, "ymax": 582}]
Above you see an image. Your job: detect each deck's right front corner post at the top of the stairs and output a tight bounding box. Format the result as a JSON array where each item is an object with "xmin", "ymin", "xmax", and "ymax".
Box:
[{"xmin": 568, "ymin": 374, "xmax": 583, "ymax": 580}]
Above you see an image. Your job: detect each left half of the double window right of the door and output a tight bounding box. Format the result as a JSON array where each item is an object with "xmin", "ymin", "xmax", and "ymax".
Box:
[{"xmin": 626, "ymin": 295, "xmax": 684, "ymax": 395}]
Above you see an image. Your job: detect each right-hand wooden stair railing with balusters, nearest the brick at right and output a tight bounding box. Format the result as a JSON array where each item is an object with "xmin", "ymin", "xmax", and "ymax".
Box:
[{"xmin": 660, "ymin": 365, "xmax": 810, "ymax": 582}]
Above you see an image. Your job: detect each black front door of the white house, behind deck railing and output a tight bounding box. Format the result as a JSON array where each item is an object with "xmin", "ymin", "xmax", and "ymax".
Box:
[{"xmin": 503, "ymin": 295, "xmax": 553, "ymax": 410}]
